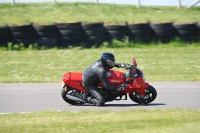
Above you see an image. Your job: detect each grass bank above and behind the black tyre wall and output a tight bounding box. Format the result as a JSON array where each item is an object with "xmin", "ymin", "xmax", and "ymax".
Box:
[{"xmin": 0, "ymin": 2, "xmax": 200, "ymax": 25}]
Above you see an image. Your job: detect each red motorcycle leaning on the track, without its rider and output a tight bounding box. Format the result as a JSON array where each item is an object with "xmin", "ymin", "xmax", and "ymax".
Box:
[{"xmin": 61, "ymin": 58, "xmax": 157, "ymax": 105}]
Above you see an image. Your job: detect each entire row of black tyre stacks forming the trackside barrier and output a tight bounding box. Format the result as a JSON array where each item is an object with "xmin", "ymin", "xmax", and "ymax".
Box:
[{"xmin": 0, "ymin": 22, "xmax": 200, "ymax": 47}]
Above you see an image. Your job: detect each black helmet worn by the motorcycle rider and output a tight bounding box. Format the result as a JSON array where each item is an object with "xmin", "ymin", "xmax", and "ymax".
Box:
[{"xmin": 101, "ymin": 52, "xmax": 115, "ymax": 69}]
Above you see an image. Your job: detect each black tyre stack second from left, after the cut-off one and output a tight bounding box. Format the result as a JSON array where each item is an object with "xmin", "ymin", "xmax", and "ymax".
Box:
[{"xmin": 8, "ymin": 24, "xmax": 34, "ymax": 47}]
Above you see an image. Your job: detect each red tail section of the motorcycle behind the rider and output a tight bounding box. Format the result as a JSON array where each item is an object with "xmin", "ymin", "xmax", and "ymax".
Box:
[{"xmin": 62, "ymin": 72, "xmax": 87, "ymax": 92}]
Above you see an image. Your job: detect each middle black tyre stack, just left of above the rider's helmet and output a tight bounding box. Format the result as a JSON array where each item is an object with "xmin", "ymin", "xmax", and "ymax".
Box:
[{"xmin": 82, "ymin": 22, "xmax": 105, "ymax": 47}]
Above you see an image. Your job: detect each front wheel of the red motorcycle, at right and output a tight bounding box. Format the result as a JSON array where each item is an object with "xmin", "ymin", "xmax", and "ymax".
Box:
[{"xmin": 129, "ymin": 85, "xmax": 157, "ymax": 104}]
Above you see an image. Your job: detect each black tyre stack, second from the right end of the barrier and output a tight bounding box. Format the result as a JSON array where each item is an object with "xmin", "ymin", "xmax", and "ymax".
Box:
[{"xmin": 150, "ymin": 22, "xmax": 175, "ymax": 43}]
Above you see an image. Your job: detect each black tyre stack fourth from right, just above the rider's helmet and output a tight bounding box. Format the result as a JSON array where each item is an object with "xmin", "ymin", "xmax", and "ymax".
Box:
[{"xmin": 104, "ymin": 25, "xmax": 129, "ymax": 42}]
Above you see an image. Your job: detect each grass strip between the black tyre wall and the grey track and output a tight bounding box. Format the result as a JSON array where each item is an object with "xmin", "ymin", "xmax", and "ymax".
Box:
[{"xmin": 0, "ymin": 43, "xmax": 200, "ymax": 83}]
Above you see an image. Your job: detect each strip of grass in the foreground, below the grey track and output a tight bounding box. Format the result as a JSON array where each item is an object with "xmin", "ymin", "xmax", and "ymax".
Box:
[{"xmin": 0, "ymin": 109, "xmax": 200, "ymax": 133}]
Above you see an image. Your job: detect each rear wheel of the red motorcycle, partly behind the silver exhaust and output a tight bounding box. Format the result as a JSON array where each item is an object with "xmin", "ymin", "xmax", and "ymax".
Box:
[{"xmin": 61, "ymin": 87, "xmax": 84, "ymax": 105}]
